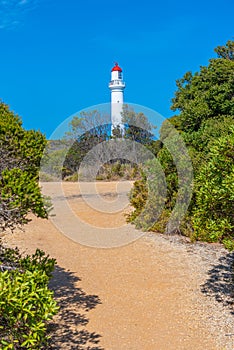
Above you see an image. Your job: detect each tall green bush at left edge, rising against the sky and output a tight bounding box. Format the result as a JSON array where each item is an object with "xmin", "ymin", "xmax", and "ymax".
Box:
[{"xmin": 0, "ymin": 102, "xmax": 48, "ymax": 230}]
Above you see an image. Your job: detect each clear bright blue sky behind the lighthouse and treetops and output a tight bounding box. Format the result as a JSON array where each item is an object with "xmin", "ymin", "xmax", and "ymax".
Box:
[{"xmin": 0, "ymin": 0, "xmax": 234, "ymax": 136}]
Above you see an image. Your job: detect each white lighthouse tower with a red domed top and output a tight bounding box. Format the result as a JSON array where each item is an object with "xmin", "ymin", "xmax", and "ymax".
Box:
[{"xmin": 109, "ymin": 63, "xmax": 125, "ymax": 131}]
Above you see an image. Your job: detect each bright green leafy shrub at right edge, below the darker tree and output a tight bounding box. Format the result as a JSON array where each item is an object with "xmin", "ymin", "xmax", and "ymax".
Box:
[{"xmin": 192, "ymin": 131, "xmax": 234, "ymax": 248}]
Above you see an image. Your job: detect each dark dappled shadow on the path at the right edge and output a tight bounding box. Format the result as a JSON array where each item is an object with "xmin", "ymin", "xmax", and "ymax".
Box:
[{"xmin": 201, "ymin": 253, "xmax": 234, "ymax": 315}]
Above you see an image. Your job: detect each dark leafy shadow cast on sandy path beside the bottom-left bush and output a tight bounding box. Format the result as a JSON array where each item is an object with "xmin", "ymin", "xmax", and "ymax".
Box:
[{"xmin": 47, "ymin": 266, "xmax": 103, "ymax": 350}]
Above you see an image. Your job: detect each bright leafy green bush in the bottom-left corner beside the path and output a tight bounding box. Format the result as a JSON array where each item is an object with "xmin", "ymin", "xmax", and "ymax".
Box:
[{"xmin": 0, "ymin": 247, "xmax": 58, "ymax": 350}]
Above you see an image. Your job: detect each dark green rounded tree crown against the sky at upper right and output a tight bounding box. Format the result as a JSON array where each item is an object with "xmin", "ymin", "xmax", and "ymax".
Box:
[{"xmin": 171, "ymin": 41, "xmax": 234, "ymax": 133}]
